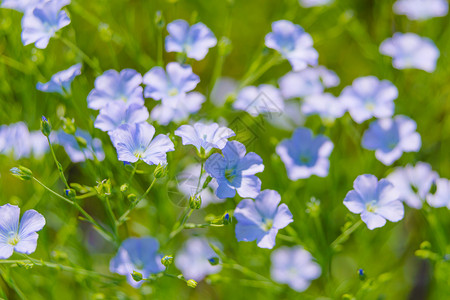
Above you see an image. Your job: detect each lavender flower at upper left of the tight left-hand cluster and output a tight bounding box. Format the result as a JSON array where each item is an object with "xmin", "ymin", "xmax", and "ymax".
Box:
[{"xmin": 87, "ymin": 69, "xmax": 144, "ymax": 109}]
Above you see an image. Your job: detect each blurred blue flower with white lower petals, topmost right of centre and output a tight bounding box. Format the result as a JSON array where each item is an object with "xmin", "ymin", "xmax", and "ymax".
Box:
[{"xmin": 266, "ymin": 20, "xmax": 319, "ymax": 71}]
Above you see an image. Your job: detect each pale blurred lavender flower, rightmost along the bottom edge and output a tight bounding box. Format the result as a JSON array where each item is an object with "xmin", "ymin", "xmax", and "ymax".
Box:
[{"xmin": 270, "ymin": 246, "xmax": 321, "ymax": 292}]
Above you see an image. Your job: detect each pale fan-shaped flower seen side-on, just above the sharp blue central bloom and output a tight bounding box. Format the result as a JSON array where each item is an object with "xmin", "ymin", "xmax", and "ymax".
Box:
[{"xmin": 175, "ymin": 122, "xmax": 236, "ymax": 153}]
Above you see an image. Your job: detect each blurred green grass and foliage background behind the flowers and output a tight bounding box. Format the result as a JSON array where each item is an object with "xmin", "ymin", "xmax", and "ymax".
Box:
[{"xmin": 0, "ymin": 0, "xmax": 450, "ymax": 300}]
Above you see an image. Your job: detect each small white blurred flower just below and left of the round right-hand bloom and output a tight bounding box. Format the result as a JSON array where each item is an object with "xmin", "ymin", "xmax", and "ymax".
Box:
[{"xmin": 302, "ymin": 93, "xmax": 345, "ymax": 122}]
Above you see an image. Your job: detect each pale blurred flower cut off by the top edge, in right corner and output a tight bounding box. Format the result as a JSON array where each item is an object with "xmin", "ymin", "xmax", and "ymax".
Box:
[{"xmin": 394, "ymin": 0, "xmax": 448, "ymax": 20}]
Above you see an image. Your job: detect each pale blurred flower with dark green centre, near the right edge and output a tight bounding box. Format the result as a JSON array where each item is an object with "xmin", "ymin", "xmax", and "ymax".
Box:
[{"xmin": 386, "ymin": 162, "xmax": 439, "ymax": 209}]
